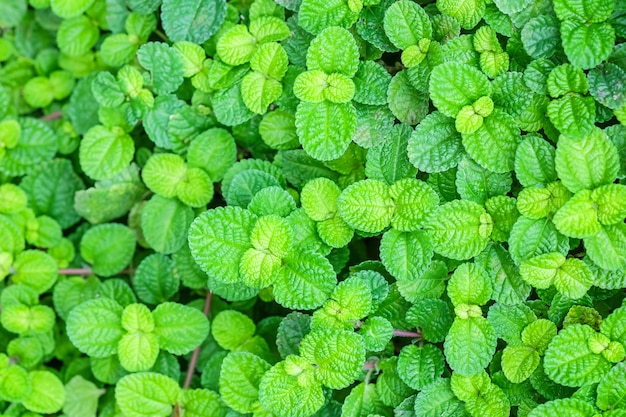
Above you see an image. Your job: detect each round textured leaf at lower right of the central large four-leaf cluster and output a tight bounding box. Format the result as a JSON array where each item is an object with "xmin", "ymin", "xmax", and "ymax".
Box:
[{"xmin": 274, "ymin": 251, "xmax": 337, "ymax": 310}]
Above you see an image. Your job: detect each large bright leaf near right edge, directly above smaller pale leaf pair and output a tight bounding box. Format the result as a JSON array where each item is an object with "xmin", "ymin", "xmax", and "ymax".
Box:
[{"xmin": 555, "ymin": 128, "xmax": 619, "ymax": 193}]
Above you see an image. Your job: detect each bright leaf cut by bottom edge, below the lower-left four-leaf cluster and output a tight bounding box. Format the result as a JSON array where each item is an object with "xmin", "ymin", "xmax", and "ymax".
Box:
[{"xmin": 115, "ymin": 372, "xmax": 180, "ymax": 417}]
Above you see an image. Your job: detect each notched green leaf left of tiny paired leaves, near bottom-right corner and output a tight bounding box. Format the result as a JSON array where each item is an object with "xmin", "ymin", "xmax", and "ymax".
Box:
[{"xmin": 544, "ymin": 324, "xmax": 611, "ymax": 387}]
